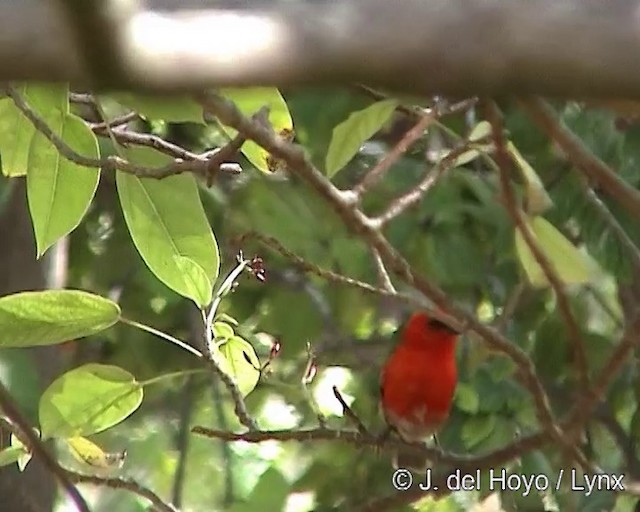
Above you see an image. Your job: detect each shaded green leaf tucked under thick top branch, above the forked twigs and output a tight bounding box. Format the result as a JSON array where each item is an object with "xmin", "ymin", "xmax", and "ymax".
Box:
[{"xmin": 109, "ymin": 93, "xmax": 204, "ymax": 124}]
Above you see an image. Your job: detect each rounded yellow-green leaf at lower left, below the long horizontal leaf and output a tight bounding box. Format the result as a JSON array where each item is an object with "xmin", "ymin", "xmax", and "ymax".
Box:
[{"xmin": 39, "ymin": 363, "xmax": 143, "ymax": 438}]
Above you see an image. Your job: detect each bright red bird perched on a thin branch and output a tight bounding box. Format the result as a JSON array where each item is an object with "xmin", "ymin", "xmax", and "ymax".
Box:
[{"xmin": 380, "ymin": 312, "xmax": 459, "ymax": 464}]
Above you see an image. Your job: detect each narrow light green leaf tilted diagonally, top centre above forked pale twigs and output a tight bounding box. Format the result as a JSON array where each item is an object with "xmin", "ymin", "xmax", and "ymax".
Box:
[{"xmin": 325, "ymin": 100, "xmax": 398, "ymax": 178}]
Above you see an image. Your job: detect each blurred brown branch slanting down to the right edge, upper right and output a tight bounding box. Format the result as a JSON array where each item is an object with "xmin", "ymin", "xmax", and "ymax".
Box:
[{"xmin": 520, "ymin": 97, "xmax": 640, "ymax": 219}]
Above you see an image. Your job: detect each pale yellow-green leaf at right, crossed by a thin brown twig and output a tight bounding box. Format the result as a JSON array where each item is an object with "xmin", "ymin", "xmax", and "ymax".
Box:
[{"xmin": 515, "ymin": 217, "xmax": 598, "ymax": 288}]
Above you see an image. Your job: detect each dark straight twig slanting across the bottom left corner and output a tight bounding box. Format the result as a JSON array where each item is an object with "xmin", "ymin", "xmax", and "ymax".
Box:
[{"xmin": 0, "ymin": 382, "xmax": 89, "ymax": 512}]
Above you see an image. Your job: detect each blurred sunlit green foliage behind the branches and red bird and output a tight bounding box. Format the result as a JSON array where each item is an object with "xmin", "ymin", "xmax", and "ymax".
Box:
[{"xmin": 0, "ymin": 81, "xmax": 640, "ymax": 512}]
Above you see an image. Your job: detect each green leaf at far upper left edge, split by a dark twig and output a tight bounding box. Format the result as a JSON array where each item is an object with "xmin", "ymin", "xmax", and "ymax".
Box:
[{"xmin": 0, "ymin": 84, "xmax": 69, "ymax": 176}]
